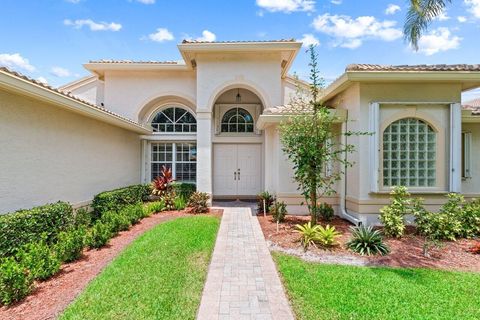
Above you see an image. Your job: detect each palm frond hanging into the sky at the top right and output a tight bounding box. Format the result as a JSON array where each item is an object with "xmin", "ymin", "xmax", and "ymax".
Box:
[{"xmin": 403, "ymin": 0, "xmax": 452, "ymax": 50}]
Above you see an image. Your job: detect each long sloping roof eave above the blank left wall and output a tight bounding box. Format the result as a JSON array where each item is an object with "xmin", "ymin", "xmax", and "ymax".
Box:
[{"xmin": 0, "ymin": 71, "xmax": 152, "ymax": 134}]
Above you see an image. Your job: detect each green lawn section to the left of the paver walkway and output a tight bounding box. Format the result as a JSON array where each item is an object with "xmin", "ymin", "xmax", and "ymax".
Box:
[{"xmin": 60, "ymin": 216, "xmax": 219, "ymax": 320}]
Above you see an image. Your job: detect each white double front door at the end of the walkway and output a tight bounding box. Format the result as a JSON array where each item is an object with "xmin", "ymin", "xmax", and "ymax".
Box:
[{"xmin": 213, "ymin": 144, "xmax": 262, "ymax": 196}]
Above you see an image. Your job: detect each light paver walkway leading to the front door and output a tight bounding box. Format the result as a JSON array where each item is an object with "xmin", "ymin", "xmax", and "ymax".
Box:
[{"xmin": 197, "ymin": 207, "xmax": 294, "ymax": 320}]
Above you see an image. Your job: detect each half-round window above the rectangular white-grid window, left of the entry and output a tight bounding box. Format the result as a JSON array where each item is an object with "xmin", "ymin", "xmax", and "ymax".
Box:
[{"xmin": 152, "ymin": 107, "xmax": 197, "ymax": 132}]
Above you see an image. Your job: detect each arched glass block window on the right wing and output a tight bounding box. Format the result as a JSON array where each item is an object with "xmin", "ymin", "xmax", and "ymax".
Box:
[{"xmin": 383, "ymin": 118, "xmax": 437, "ymax": 187}]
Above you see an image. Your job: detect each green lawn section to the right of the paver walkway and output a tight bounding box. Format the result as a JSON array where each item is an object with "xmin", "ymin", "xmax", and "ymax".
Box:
[{"xmin": 274, "ymin": 253, "xmax": 480, "ymax": 320}]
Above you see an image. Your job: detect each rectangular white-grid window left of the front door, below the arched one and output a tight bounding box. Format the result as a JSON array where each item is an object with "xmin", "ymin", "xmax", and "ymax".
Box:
[{"xmin": 150, "ymin": 142, "xmax": 197, "ymax": 182}]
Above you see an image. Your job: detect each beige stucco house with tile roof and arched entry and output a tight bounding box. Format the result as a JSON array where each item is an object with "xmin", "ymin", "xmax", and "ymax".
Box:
[{"xmin": 0, "ymin": 40, "xmax": 480, "ymax": 223}]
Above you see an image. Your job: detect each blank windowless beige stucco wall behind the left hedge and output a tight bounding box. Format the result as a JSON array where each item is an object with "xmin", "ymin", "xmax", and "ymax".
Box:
[{"xmin": 0, "ymin": 91, "xmax": 140, "ymax": 213}]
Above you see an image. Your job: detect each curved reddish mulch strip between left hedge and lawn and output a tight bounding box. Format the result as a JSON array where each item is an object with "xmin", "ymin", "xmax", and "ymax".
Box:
[{"xmin": 0, "ymin": 209, "xmax": 223, "ymax": 320}]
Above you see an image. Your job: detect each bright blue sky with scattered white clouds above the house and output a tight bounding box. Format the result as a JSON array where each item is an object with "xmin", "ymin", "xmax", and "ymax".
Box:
[{"xmin": 0, "ymin": 0, "xmax": 480, "ymax": 98}]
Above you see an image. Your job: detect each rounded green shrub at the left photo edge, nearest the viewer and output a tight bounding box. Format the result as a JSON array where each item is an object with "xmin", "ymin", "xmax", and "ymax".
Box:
[{"xmin": 0, "ymin": 257, "xmax": 33, "ymax": 305}]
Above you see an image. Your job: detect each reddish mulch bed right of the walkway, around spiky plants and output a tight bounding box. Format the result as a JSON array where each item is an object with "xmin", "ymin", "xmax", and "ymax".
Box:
[{"xmin": 258, "ymin": 216, "xmax": 480, "ymax": 272}]
